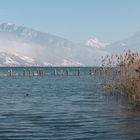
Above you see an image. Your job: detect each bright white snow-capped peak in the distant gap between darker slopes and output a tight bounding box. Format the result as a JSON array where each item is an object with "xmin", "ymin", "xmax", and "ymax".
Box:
[{"xmin": 85, "ymin": 37, "xmax": 108, "ymax": 49}]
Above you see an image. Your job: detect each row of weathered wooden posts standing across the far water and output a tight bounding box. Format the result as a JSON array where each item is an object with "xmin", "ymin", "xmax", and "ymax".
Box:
[{"xmin": 0, "ymin": 68, "xmax": 96, "ymax": 77}]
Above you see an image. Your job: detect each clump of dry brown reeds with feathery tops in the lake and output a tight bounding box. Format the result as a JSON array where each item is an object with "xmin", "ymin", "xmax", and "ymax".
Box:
[{"xmin": 101, "ymin": 50, "xmax": 140, "ymax": 105}]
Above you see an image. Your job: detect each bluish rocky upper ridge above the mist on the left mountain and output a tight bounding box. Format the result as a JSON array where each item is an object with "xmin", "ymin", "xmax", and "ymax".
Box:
[{"xmin": 0, "ymin": 23, "xmax": 74, "ymax": 47}]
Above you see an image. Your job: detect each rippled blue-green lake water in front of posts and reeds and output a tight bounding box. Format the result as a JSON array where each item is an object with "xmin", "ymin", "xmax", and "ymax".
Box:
[{"xmin": 0, "ymin": 68, "xmax": 140, "ymax": 140}]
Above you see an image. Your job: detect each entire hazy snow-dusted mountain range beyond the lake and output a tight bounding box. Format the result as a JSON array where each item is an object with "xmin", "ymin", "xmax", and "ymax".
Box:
[{"xmin": 0, "ymin": 23, "xmax": 140, "ymax": 66}]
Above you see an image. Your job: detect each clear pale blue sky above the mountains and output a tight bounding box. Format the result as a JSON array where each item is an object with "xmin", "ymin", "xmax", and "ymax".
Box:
[{"xmin": 0, "ymin": 0, "xmax": 140, "ymax": 42}]
